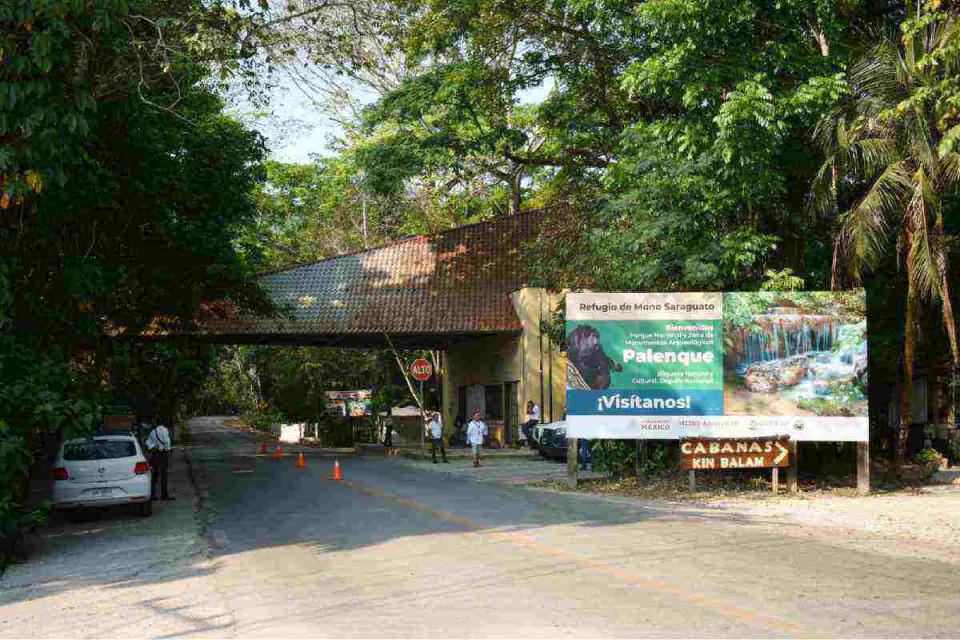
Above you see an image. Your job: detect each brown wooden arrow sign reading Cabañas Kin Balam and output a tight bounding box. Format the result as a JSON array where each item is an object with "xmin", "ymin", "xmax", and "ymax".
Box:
[{"xmin": 680, "ymin": 436, "xmax": 790, "ymax": 471}]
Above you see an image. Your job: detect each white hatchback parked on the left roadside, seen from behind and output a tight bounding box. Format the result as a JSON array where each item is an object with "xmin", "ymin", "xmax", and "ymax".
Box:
[{"xmin": 53, "ymin": 434, "xmax": 153, "ymax": 516}]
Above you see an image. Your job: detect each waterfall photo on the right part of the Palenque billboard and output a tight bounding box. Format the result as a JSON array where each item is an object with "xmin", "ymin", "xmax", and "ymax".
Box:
[{"xmin": 723, "ymin": 291, "xmax": 867, "ymax": 417}]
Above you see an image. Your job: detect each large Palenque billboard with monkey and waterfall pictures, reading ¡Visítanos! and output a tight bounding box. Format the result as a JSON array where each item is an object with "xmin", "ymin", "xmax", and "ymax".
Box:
[{"xmin": 566, "ymin": 290, "xmax": 869, "ymax": 442}]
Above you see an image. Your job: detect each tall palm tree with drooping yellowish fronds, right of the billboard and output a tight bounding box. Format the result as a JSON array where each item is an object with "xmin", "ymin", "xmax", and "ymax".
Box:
[{"xmin": 811, "ymin": 13, "xmax": 960, "ymax": 468}]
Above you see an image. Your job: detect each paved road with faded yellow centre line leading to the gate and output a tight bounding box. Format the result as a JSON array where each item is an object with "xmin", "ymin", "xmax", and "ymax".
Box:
[{"xmin": 0, "ymin": 418, "xmax": 960, "ymax": 638}]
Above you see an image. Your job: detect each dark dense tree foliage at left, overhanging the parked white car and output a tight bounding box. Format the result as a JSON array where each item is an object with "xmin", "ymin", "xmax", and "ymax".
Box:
[{"xmin": 0, "ymin": 0, "xmax": 269, "ymax": 556}]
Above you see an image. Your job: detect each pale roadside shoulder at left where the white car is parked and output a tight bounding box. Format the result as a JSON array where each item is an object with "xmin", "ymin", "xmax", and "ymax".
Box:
[{"xmin": 0, "ymin": 449, "xmax": 230, "ymax": 637}]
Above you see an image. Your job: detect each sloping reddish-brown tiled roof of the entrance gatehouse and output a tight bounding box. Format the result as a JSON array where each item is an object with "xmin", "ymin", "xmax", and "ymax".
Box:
[{"xmin": 199, "ymin": 211, "xmax": 545, "ymax": 335}]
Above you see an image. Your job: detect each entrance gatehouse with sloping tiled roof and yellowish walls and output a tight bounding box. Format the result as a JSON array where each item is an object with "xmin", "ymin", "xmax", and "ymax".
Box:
[{"xmin": 195, "ymin": 211, "xmax": 566, "ymax": 444}]
